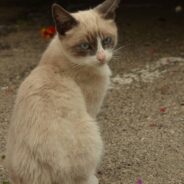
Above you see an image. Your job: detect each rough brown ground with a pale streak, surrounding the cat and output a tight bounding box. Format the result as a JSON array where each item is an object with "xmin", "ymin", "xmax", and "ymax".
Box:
[{"xmin": 0, "ymin": 7, "xmax": 184, "ymax": 184}]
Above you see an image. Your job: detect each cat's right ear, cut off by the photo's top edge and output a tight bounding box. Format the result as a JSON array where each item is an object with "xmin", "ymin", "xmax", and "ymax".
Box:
[{"xmin": 95, "ymin": 0, "xmax": 121, "ymax": 19}]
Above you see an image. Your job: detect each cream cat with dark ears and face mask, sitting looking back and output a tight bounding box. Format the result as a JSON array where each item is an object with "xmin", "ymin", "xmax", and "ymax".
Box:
[{"xmin": 6, "ymin": 0, "xmax": 120, "ymax": 184}]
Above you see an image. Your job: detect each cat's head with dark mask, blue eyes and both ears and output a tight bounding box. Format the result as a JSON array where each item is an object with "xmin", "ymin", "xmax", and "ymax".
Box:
[{"xmin": 52, "ymin": 0, "xmax": 120, "ymax": 66}]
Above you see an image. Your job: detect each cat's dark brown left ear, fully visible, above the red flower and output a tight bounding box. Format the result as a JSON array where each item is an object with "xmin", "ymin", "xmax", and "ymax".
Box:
[{"xmin": 52, "ymin": 3, "xmax": 79, "ymax": 35}]
